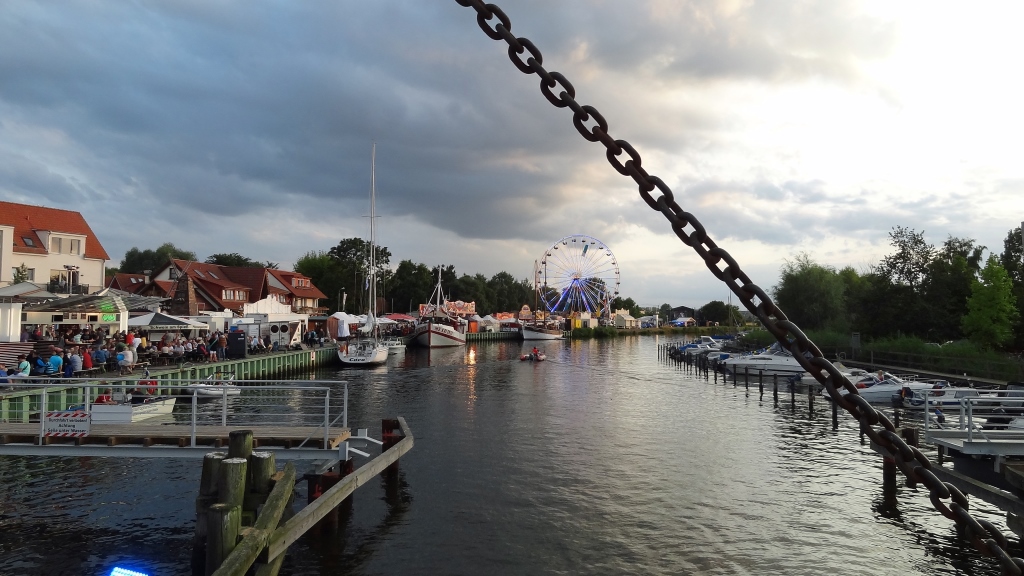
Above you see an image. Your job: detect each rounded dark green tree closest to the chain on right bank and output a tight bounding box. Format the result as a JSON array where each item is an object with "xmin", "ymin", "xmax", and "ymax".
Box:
[{"xmin": 772, "ymin": 253, "xmax": 849, "ymax": 330}]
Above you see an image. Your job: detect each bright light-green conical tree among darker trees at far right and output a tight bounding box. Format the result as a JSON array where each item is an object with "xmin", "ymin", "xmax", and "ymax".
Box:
[{"xmin": 962, "ymin": 256, "xmax": 1018, "ymax": 348}]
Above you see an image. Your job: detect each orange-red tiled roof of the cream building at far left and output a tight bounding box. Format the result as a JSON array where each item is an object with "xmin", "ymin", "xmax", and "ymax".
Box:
[{"xmin": 0, "ymin": 202, "xmax": 111, "ymax": 260}]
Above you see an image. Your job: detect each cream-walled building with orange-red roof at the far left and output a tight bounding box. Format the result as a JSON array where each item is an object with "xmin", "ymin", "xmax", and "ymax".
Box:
[{"xmin": 0, "ymin": 202, "xmax": 110, "ymax": 294}]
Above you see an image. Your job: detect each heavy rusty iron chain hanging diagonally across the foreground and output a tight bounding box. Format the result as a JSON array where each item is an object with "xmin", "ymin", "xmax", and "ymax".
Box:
[{"xmin": 456, "ymin": 0, "xmax": 1024, "ymax": 576}]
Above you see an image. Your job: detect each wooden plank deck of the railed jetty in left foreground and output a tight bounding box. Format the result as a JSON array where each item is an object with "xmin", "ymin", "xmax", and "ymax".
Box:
[{"xmin": 0, "ymin": 422, "xmax": 351, "ymax": 450}]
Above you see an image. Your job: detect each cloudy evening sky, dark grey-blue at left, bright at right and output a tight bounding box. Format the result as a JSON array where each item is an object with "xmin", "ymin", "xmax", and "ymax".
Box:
[{"xmin": 0, "ymin": 0, "xmax": 1024, "ymax": 305}]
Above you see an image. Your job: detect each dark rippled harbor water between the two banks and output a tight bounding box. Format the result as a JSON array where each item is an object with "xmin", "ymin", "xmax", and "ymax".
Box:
[{"xmin": 0, "ymin": 337, "xmax": 1005, "ymax": 576}]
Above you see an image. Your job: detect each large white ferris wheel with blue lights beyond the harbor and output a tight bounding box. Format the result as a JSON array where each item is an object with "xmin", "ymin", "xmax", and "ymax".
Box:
[{"xmin": 534, "ymin": 234, "xmax": 618, "ymax": 318}]
